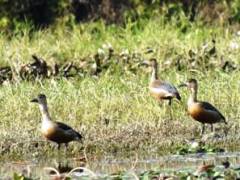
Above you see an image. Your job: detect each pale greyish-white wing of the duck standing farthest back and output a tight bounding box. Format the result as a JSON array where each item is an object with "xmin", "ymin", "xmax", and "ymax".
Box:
[{"xmin": 151, "ymin": 80, "xmax": 181, "ymax": 100}]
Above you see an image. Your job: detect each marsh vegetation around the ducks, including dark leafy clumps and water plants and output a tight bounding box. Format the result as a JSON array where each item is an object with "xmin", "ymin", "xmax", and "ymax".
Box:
[{"xmin": 0, "ymin": 0, "xmax": 240, "ymax": 179}]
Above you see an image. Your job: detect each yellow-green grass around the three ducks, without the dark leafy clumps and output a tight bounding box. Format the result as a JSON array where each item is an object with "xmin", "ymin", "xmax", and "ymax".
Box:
[{"xmin": 0, "ymin": 18, "xmax": 240, "ymax": 165}]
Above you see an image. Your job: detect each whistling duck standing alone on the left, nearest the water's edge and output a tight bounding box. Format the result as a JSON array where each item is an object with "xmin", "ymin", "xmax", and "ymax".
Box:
[{"xmin": 31, "ymin": 94, "xmax": 82, "ymax": 149}]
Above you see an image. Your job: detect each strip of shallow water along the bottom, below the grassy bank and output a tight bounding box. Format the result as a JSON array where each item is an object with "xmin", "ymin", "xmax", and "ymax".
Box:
[{"xmin": 0, "ymin": 152, "xmax": 240, "ymax": 179}]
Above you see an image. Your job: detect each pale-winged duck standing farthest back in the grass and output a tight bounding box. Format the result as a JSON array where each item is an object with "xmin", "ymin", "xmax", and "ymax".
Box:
[{"xmin": 147, "ymin": 58, "xmax": 181, "ymax": 105}]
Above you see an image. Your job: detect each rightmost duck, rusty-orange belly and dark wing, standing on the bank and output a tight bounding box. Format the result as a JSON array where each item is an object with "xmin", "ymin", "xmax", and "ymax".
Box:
[{"xmin": 180, "ymin": 79, "xmax": 227, "ymax": 134}]
